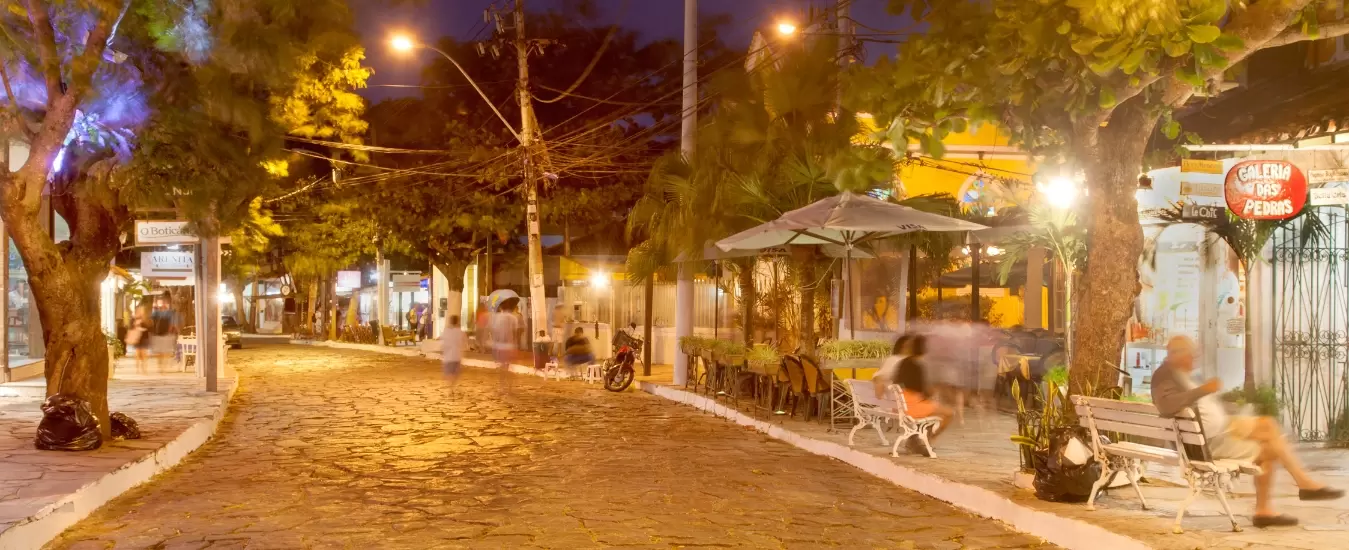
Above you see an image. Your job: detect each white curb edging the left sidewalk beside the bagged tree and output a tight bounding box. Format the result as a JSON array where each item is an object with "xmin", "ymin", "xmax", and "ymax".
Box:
[{"xmin": 0, "ymin": 380, "xmax": 239, "ymax": 550}]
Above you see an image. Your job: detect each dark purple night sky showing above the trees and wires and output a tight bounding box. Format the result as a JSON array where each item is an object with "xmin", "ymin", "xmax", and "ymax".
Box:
[{"xmin": 349, "ymin": 0, "xmax": 907, "ymax": 101}]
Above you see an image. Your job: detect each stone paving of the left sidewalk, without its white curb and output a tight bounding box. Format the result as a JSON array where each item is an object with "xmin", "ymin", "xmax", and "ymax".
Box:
[{"xmin": 0, "ymin": 361, "xmax": 232, "ymax": 539}]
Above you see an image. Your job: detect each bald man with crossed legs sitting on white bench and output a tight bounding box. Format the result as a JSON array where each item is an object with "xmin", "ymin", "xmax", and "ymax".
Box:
[{"xmin": 1152, "ymin": 336, "xmax": 1344, "ymax": 527}]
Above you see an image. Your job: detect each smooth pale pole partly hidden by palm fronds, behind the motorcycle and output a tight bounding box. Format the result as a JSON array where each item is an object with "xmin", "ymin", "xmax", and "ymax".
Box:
[{"xmin": 671, "ymin": 0, "xmax": 697, "ymax": 386}]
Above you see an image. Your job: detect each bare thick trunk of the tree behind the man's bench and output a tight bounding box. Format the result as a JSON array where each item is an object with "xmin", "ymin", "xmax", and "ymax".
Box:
[{"xmin": 1067, "ymin": 97, "xmax": 1157, "ymax": 395}]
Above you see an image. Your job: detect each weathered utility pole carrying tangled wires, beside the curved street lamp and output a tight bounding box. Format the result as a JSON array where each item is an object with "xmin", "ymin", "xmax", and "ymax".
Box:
[{"xmin": 515, "ymin": 0, "xmax": 549, "ymax": 341}]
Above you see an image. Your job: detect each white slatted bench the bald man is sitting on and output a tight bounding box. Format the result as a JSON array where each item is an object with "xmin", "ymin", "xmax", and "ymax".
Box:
[{"xmin": 1072, "ymin": 395, "xmax": 1260, "ymax": 534}]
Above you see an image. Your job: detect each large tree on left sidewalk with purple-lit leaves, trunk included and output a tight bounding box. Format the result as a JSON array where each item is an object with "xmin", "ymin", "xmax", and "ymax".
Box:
[{"xmin": 0, "ymin": 0, "xmax": 369, "ymax": 435}]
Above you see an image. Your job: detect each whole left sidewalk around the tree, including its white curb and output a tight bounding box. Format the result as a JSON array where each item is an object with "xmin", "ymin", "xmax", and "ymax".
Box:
[{"xmin": 0, "ymin": 360, "xmax": 235, "ymax": 550}]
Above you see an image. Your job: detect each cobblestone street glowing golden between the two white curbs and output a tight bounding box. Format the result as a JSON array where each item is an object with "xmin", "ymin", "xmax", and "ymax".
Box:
[{"xmin": 50, "ymin": 345, "xmax": 1041, "ymax": 549}]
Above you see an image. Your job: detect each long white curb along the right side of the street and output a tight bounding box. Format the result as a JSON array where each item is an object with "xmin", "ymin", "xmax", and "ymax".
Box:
[{"xmin": 637, "ymin": 381, "xmax": 1151, "ymax": 550}]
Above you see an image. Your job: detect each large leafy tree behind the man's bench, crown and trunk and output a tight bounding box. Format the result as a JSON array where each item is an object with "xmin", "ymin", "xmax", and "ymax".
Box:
[{"xmin": 850, "ymin": 0, "xmax": 1349, "ymax": 391}]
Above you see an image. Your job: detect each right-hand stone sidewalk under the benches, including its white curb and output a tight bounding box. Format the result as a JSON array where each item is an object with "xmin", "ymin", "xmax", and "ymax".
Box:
[{"xmin": 641, "ymin": 383, "xmax": 1349, "ymax": 549}]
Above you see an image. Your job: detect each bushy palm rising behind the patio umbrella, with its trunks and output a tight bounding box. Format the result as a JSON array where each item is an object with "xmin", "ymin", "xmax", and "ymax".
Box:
[{"xmin": 629, "ymin": 39, "xmax": 894, "ymax": 352}]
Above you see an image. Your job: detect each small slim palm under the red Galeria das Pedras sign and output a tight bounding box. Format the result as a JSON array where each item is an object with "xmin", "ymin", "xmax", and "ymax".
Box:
[{"xmin": 1147, "ymin": 205, "xmax": 1334, "ymax": 394}]
